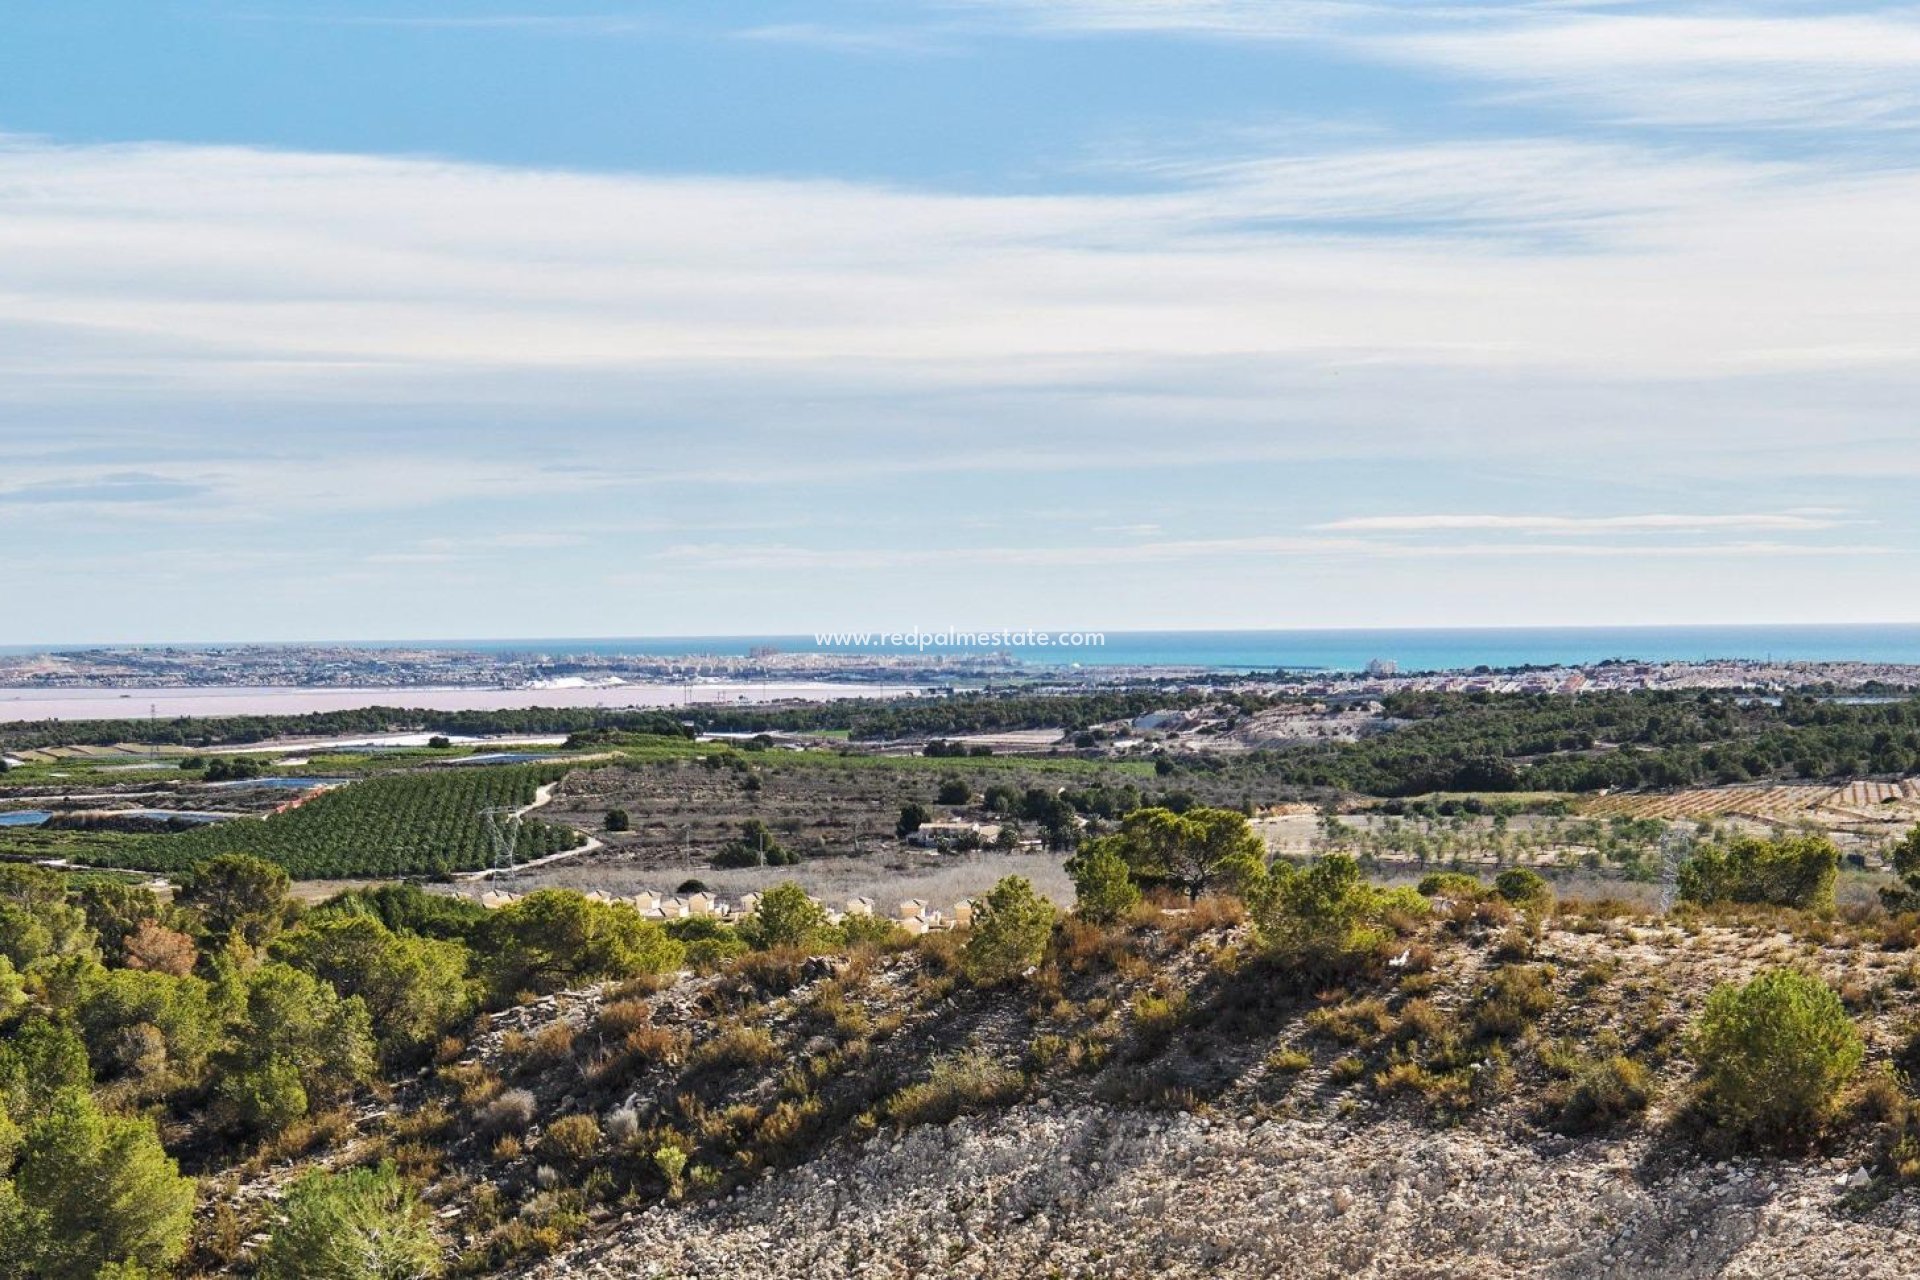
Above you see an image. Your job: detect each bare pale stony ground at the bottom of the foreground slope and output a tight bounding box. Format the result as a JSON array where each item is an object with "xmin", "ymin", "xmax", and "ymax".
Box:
[{"xmin": 534, "ymin": 1102, "xmax": 1920, "ymax": 1280}]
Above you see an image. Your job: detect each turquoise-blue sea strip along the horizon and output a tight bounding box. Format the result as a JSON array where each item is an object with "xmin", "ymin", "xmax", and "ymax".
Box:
[{"xmin": 11, "ymin": 624, "xmax": 1920, "ymax": 672}]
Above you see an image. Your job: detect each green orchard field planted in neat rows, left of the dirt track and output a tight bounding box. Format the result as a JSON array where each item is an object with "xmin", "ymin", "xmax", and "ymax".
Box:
[{"xmin": 58, "ymin": 766, "xmax": 586, "ymax": 879}]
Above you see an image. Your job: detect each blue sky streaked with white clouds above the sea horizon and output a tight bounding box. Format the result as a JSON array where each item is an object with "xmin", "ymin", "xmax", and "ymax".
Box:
[{"xmin": 0, "ymin": 0, "xmax": 1920, "ymax": 645}]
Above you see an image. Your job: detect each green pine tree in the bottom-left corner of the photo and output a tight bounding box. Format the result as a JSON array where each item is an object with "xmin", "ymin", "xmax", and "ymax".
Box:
[{"xmin": 0, "ymin": 1090, "xmax": 194, "ymax": 1280}]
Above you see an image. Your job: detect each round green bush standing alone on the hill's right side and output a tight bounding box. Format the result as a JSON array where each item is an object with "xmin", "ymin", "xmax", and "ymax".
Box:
[{"xmin": 1692, "ymin": 969, "xmax": 1864, "ymax": 1146}]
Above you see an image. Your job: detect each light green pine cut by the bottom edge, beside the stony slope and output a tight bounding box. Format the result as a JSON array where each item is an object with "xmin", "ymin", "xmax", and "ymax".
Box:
[{"xmin": 257, "ymin": 1163, "xmax": 440, "ymax": 1280}]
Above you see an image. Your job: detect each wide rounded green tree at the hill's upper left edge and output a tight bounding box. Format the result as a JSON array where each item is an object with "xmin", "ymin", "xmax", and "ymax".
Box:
[{"xmin": 480, "ymin": 889, "xmax": 685, "ymax": 994}]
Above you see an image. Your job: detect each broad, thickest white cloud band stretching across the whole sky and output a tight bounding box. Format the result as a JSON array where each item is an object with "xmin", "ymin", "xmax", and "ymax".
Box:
[{"xmin": 0, "ymin": 132, "xmax": 1920, "ymax": 395}]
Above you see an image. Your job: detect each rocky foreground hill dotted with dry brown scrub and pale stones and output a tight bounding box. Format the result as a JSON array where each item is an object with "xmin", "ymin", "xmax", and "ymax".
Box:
[{"xmin": 291, "ymin": 898, "xmax": 1920, "ymax": 1278}]
